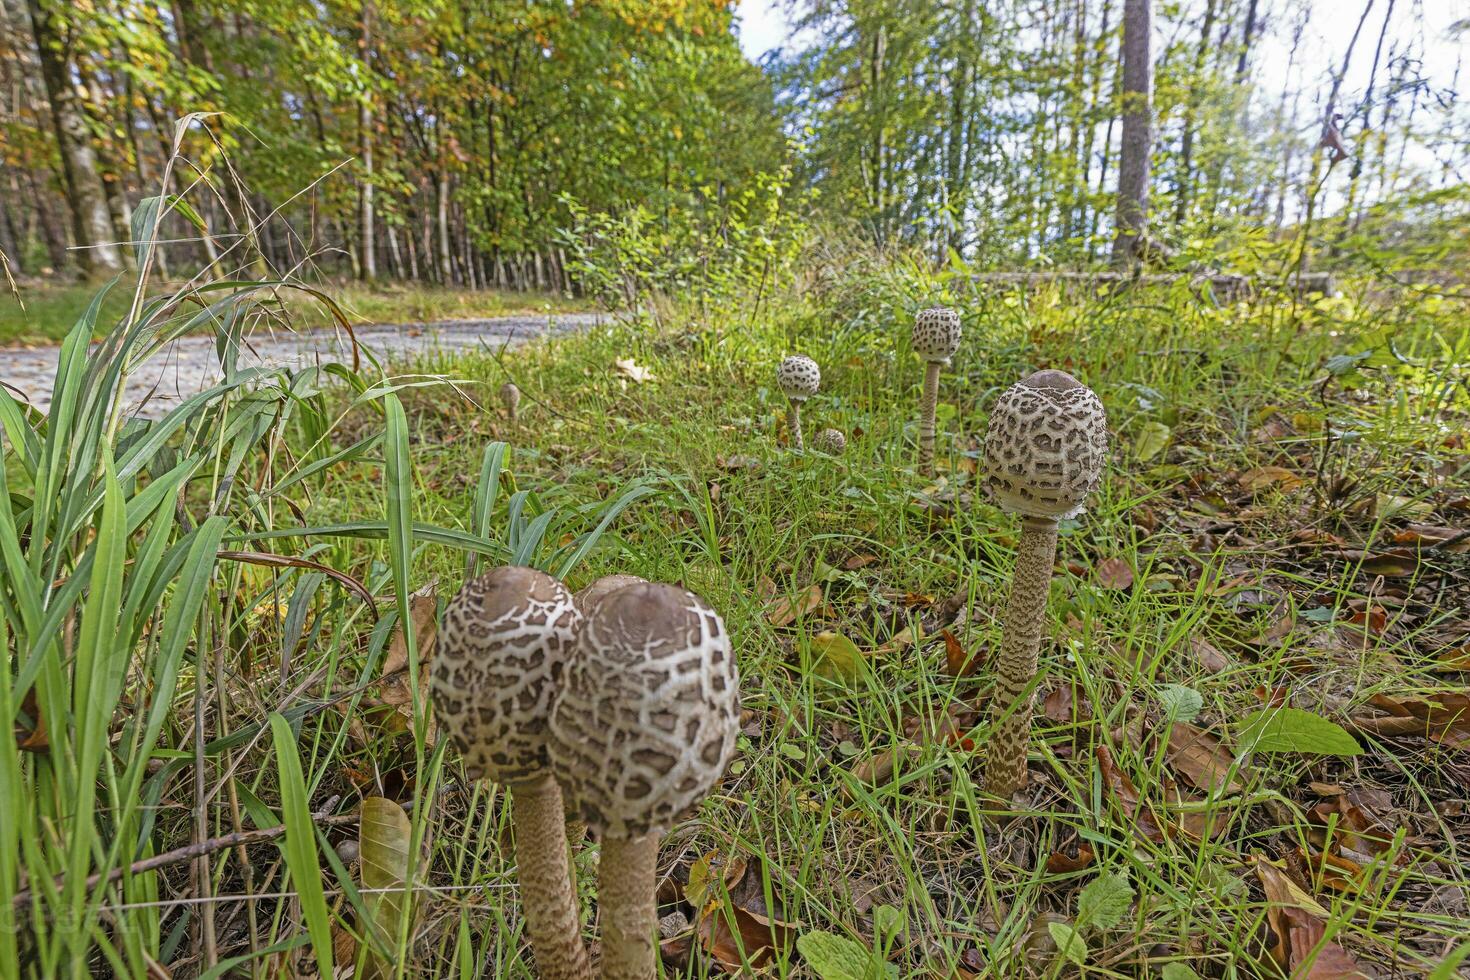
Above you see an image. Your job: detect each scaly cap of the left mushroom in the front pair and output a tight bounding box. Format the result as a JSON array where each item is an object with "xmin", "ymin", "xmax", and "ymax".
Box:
[{"xmin": 429, "ymin": 566, "xmax": 582, "ymax": 783}]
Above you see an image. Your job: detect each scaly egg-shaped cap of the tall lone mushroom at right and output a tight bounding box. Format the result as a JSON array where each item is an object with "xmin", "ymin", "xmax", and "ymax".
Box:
[{"xmin": 985, "ymin": 370, "xmax": 1107, "ymax": 520}]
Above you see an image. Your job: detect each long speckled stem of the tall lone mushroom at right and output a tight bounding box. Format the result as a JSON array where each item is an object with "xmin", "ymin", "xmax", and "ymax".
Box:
[{"xmin": 985, "ymin": 517, "xmax": 1057, "ymax": 799}]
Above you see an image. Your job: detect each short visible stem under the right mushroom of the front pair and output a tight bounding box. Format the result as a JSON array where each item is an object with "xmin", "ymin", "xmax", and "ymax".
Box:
[{"xmin": 597, "ymin": 833, "xmax": 659, "ymax": 980}]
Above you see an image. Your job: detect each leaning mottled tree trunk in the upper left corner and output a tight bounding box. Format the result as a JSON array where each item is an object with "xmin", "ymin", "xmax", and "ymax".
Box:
[{"xmin": 29, "ymin": 0, "xmax": 122, "ymax": 276}]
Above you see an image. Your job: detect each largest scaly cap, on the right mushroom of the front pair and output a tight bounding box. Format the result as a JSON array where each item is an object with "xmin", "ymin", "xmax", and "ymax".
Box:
[{"xmin": 551, "ymin": 583, "xmax": 739, "ymax": 839}]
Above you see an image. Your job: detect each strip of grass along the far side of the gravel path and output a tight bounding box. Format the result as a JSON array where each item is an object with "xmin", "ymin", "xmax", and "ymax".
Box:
[{"xmin": 0, "ymin": 281, "xmax": 589, "ymax": 345}]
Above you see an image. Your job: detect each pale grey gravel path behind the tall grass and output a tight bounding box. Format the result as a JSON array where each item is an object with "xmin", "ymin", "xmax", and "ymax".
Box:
[{"xmin": 0, "ymin": 313, "xmax": 603, "ymax": 417}]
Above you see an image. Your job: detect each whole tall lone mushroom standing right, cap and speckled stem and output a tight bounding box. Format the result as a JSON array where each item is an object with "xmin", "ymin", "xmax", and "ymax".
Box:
[{"xmin": 985, "ymin": 370, "xmax": 1107, "ymax": 798}]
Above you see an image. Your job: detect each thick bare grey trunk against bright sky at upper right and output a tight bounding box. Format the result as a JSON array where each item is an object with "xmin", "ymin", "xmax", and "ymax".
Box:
[{"xmin": 1113, "ymin": 0, "xmax": 1154, "ymax": 266}]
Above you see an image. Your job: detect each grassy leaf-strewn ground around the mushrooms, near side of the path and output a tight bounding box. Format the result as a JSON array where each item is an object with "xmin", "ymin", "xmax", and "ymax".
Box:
[{"xmin": 0, "ymin": 262, "xmax": 1470, "ymax": 977}]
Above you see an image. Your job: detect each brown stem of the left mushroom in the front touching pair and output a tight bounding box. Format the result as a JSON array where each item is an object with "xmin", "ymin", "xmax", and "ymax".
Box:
[{"xmin": 510, "ymin": 776, "xmax": 592, "ymax": 980}]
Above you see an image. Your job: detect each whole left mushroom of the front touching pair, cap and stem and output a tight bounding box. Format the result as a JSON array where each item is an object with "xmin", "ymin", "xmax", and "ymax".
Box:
[{"xmin": 431, "ymin": 567, "xmax": 592, "ymax": 980}]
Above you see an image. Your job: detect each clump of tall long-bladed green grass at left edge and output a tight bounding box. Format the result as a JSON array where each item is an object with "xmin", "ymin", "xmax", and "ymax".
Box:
[{"xmin": 0, "ymin": 188, "xmax": 651, "ymax": 977}]
